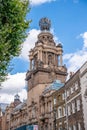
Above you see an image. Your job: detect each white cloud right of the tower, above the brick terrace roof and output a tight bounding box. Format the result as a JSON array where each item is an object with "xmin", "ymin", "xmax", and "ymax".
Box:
[{"xmin": 64, "ymin": 32, "xmax": 87, "ymax": 72}]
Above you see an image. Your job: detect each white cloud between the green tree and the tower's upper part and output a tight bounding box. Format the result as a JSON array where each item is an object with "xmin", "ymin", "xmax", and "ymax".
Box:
[{"xmin": 20, "ymin": 29, "xmax": 40, "ymax": 61}]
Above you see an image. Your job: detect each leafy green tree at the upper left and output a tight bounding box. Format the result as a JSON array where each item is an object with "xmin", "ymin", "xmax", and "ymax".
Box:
[{"xmin": 0, "ymin": 0, "xmax": 31, "ymax": 83}]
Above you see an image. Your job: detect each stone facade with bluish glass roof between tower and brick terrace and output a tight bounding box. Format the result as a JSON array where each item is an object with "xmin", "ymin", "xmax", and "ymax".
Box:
[{"xmin": 39, "ymin": 80, "xmax": 63, "ymax": 130}]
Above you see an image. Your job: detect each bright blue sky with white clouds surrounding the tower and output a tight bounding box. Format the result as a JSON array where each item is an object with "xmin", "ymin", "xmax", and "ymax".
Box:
[{"xmin": 0, "ymin": 0, "xmax": 87, "ymax": 103}]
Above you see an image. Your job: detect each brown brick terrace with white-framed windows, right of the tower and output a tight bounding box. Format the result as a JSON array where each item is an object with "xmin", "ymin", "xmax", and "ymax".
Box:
[{"xmin": 53, "ymin": 62, "xmax": 87, "ymax": 130}]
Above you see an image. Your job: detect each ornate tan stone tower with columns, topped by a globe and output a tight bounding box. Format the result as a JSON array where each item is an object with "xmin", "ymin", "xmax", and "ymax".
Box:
[{"xmin": 26, "ymin": 18, "xmax": 67, "ymax": 106}]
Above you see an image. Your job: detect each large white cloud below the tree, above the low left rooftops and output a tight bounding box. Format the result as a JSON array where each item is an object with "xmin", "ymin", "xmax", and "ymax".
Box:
[{"xmin": 0, "ymin": 73, "xmax": 27, "ymax": 103}]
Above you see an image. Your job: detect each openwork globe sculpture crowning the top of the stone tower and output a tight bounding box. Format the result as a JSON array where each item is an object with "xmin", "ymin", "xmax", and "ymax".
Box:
[{"xmin": 39, "ymin": 17, "xmax": 51, "ymax": 31}]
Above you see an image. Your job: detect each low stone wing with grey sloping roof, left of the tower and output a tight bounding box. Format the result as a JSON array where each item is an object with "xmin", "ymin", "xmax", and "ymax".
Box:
[{"xmin": 10, "ymin": 101, "xmax": 27, "ymax": 130}]
